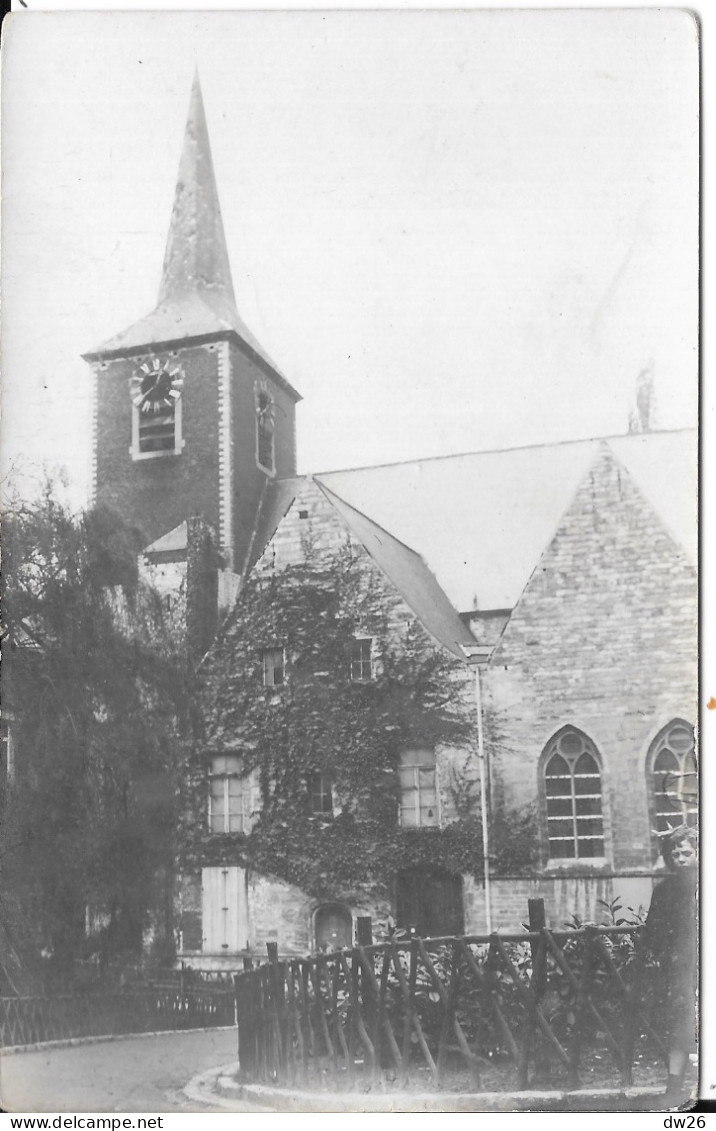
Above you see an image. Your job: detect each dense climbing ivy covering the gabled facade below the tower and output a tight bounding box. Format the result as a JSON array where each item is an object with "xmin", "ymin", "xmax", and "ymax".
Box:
[{"xmin": 186, "ymin": 539, "xmax": 536, "ymax": 898}]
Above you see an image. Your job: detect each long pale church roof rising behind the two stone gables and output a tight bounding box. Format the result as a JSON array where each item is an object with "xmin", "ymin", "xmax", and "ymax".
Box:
[{"xmin": 314, "ymin": 430, "xmax": 698, "ymax": 612}]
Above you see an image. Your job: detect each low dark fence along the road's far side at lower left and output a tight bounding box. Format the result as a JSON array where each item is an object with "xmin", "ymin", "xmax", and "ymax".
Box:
[{"xmin": 0, "ymin": 986, "xmax": 235, "ymax": 1048}]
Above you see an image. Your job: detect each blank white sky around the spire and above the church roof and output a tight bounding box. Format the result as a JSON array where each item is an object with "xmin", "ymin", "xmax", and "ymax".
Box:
[{"xmin": 2, "ymin": 9, "xmax": 698, "ymax": 498}]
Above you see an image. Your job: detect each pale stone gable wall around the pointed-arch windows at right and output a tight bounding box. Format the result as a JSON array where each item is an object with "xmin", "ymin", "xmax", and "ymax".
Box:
[{"xmin": 483, "ymin": 448, "xmax": 697, "ymax": 874}]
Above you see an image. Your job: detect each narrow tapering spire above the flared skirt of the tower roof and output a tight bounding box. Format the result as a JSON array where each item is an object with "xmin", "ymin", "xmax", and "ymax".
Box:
[{"xmin": 158, "ymin": 71, "xmax": 235, "ymax": 308}]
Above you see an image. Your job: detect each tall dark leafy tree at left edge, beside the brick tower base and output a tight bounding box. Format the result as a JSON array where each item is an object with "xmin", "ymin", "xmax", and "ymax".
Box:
[{"xmin": 1, "ymin": 486, "xmax": 188, "ymax": 986}]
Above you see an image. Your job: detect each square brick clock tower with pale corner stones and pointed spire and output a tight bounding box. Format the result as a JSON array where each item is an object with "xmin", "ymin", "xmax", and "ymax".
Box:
[{"xmin": 84, "ymin": 77, "xmax": 301, "ymax": 573}]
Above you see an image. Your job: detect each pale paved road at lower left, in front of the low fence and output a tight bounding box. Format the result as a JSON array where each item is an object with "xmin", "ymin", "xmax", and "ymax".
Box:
[{"xmin": 0, "ymin": 1029, "xmax": 243, "ymax": 1113}]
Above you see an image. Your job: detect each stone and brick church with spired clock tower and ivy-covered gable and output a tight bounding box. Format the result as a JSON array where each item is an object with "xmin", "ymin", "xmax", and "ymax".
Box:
[{"xmin": 85, "ymin": 79, "xmax": 698, "ymax": 969}]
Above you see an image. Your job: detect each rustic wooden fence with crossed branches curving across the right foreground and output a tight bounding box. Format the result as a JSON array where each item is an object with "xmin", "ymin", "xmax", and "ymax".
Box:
[{"xmin": 235, "ymin": 927, "xmax": 666, "ymax": 1091}]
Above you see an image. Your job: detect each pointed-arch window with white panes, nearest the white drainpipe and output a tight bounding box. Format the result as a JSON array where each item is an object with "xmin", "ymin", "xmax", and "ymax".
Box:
[{"xmin": 544, "ymin": 728, "xmax": 604, "ymax": 860}]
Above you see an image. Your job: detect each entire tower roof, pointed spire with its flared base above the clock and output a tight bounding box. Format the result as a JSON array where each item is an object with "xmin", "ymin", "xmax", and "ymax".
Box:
[{"xmin": 85, "ymin": 74, "xmax": 298, "ymax": 393}]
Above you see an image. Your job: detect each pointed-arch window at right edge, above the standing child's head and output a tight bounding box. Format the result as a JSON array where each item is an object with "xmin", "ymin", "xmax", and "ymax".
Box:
[{"xmin": 647, "ymin": 718, "xmax": 698, "ymax": 832}]
